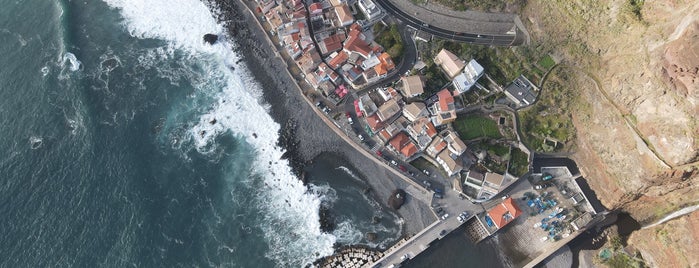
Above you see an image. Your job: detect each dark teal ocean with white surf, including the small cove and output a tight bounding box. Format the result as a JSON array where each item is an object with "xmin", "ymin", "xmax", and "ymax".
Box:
[{"xmin": 0, "ymin": 0, "xmax": 401, "ymax": 267}]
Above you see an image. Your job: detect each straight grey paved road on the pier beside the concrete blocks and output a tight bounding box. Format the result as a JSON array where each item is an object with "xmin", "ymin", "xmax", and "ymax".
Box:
[{"xmin": 369, "ymin": 187, "xmax": 483, "ymax": 267}]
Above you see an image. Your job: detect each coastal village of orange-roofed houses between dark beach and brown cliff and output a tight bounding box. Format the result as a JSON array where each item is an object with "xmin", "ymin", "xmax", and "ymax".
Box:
[{"xmin": 249, "ymin": 0, "xmax": 604, "ymax": 267}]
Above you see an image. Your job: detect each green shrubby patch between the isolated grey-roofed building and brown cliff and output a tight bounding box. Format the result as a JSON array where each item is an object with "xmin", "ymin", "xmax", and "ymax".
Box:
[{"xmin": 519, "ymin": 69, "xmax": 577, "ymax": 152}]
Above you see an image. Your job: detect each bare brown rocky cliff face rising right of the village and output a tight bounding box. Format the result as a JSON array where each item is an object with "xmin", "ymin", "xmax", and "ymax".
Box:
[{"xmin": 522, "ymin": 0, "xmax": 699, "ymax": 267}]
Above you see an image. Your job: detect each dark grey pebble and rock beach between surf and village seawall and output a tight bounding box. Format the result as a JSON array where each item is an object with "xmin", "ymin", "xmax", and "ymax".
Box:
[{"xmin": 212, "ymin": 0, "xmax": 434, "ymax": 262}]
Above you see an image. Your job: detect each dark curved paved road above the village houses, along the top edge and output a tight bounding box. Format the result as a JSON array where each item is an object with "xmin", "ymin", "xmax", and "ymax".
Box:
[{"xmin": 376, "ymin": 0, "xmax": 517, "ymax": 46}]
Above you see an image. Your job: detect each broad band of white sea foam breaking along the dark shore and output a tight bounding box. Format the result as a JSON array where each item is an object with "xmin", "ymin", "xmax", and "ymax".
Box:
[{"xmin": 105, "ymin": 0, "xmax": 336, "ymax": 267}]
